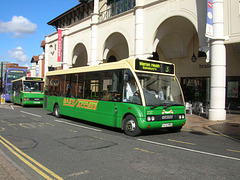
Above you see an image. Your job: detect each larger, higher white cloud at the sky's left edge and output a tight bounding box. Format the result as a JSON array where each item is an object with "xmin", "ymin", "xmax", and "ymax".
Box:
[{"xmin": 0, "ymin": 16, "xmax": 37, "ymax": 37}]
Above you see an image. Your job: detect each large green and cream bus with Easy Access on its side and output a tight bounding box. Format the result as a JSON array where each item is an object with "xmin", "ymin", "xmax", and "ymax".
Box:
[{"xmin": 43, "ymin": 59, "xmax": 186, "ymax": 136}]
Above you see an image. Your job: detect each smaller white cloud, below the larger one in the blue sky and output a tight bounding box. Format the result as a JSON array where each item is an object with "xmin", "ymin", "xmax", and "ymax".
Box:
[{"xmin": 8, "ymin": 47, "xmax": 29, "ymax": 62}]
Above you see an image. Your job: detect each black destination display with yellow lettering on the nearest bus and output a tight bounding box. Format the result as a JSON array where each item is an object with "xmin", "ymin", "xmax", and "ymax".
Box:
[{"xmin": 135, "ymin": 59, "xmax": 174, "ymax": 74}]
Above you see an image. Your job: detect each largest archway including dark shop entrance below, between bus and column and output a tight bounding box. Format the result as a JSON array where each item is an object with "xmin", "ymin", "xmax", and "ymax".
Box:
[{"xmin": 153, "ymin": 16, "xmax": 210, "ymax": 105}]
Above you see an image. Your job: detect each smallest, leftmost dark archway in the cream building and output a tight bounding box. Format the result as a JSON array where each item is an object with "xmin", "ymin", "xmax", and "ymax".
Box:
[{"xmin": 72, "ymin": 43, "xmax": 88, "ymax": 67}]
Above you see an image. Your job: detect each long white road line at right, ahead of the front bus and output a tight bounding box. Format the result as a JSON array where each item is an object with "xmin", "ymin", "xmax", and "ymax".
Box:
[{"xmin": 137, "ymin": 139, "xmax": 240, "ymax": 161}]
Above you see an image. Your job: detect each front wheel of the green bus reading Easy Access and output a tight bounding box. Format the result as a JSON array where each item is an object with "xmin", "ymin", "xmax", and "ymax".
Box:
[{"xmin": 123, "ymin": 115, "xmax": 141, "ymax": 136}]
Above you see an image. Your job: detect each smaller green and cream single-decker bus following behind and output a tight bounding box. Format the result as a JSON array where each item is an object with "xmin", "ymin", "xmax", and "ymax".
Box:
[{"xmin": 11, "ymin": 76, "xmax": 44, "ymax": 106}]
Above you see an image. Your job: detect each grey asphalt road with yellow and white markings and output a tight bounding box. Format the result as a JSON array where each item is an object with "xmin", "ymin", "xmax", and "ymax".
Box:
[{"xmin": 0, "ymin": 105, "xmax": 240, "ymax": 180}]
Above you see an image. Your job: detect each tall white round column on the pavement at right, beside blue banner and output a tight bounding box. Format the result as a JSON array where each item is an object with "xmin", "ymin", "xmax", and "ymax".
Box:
[{"xmin": 209, "ymin": 0, "xmax": 226, "ymax": 120}]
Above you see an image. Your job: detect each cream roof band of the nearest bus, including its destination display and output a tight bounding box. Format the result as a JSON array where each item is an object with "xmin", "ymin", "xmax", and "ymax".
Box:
[{"xmin": 46, "ymin": 58, "xmax": 175, "ymax": 76}]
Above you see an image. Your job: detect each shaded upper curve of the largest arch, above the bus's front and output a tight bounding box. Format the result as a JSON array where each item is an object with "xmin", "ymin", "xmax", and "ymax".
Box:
[{"xmin": 153, "ymin": 16, "xmax": 199, "ymax": 61}]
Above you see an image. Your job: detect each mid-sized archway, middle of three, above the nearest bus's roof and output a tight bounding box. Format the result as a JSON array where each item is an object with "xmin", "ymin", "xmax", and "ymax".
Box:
[{"xmin": 103, "ymin": 33, "xmax": 129, "ymax": 63}]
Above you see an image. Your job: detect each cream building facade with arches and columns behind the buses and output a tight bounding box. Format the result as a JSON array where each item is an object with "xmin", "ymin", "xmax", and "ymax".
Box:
[{"xmin": 45, "ymin": 0, "xmax": 240, "ymax": 120}]
